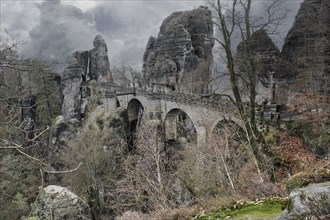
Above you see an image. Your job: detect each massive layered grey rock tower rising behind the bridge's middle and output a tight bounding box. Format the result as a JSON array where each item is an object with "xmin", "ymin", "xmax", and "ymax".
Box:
[{"xmin": 143, "ymin": 6, "xmax": 214, "ymax": 90}]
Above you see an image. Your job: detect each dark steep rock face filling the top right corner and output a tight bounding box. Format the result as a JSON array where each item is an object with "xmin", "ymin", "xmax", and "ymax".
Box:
[{"xmin": 279, "ymin": 0, "xmax": 330, "ymax": 77}]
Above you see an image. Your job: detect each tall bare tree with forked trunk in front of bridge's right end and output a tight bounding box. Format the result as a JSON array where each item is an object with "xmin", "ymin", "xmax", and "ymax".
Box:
[{"xmin": 208, "ymin": 0, "xmax": 285, "ymax": 177}]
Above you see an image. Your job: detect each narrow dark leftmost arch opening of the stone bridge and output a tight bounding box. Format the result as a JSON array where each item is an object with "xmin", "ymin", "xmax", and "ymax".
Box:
[{"xmin": 127, "ymin": 98, "xmax": 144, "ymax": 131}]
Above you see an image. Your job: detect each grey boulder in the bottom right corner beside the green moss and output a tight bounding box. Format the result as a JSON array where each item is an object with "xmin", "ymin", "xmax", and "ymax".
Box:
[{"xmin": 276, "ymin": 182, "xmax": 330, "ymax": 220}]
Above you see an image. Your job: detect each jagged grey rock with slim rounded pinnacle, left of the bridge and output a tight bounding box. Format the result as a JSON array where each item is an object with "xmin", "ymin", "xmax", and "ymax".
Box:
[{"xmin": 48, "ymin": 35, "xmax": 112, "ymax": 178}]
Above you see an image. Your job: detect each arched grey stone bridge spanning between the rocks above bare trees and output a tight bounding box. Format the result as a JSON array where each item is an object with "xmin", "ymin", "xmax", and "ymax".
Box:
[{"xmin": 101, "ymin": 83, "xmax": 241, "ymax": 145}]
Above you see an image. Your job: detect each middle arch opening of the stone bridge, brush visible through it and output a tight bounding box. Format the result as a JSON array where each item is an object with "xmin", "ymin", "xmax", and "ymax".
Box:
[{"xmin": 164, "ymin": 108, "xmax": 197, "ymax": 143}]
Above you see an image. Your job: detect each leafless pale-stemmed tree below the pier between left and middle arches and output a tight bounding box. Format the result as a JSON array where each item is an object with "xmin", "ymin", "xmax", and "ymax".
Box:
[{"xmin": 113, "ymin": 125, "xmax": 193, "ymax": 215}]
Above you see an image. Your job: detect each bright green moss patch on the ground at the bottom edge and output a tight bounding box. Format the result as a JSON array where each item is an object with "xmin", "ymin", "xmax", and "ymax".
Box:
[{"xmin": 196, "ymin": 199, "xmax": 287, "ymax": 220}]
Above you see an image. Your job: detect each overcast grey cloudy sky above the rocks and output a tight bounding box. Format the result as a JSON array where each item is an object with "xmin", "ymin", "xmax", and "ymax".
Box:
[{"xmin": 0, "ymin": 0, "xmax": 302, "ymax": 70}]
